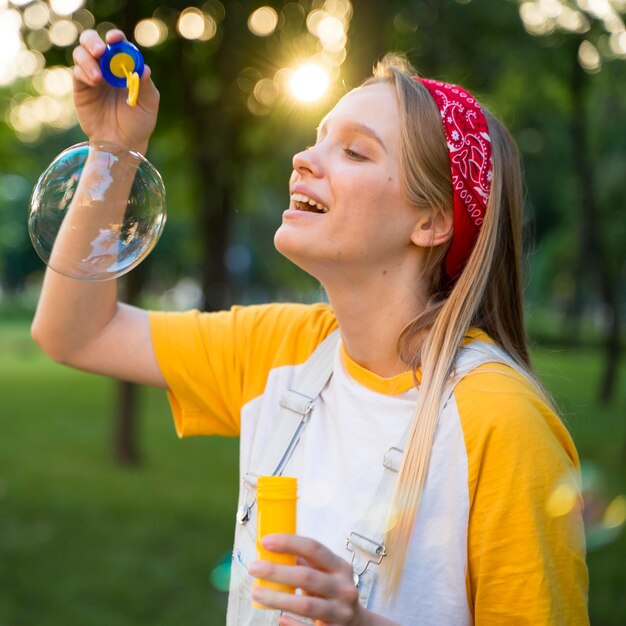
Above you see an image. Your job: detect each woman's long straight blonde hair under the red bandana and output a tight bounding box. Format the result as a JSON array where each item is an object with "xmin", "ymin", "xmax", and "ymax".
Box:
[{"xmin": 364, "ymin": 55, "xmax": 535, "ymax": 595}]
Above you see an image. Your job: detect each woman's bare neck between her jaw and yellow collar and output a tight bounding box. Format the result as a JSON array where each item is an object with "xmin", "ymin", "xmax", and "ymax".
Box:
[{"xmin": 324, "ymin": 258, "xmax": 426, "ymax": 378}]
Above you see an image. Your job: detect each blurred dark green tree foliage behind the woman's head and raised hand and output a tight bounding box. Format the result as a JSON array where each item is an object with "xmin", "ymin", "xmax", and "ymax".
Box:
[{"xmin": 0, "ymin": 0, "xmax": 626, "ymax": 314}]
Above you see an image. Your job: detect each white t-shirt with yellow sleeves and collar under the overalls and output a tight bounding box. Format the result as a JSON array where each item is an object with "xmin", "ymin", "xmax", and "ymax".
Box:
[{"xmin": 150, "ymin": 304, "xmax": 588, "ymax": 626}]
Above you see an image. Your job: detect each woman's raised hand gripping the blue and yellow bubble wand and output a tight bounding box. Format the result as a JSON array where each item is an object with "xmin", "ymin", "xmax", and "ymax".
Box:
[{"xmin": 73, "ymin": 29, "xmax": 159, "ymax": 154}]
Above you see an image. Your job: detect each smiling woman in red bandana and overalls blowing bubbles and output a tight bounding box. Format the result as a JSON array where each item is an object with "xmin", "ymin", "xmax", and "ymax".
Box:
[{"xmin": 33, "ymin": 31, "xmax": 587, "ymax": 625}]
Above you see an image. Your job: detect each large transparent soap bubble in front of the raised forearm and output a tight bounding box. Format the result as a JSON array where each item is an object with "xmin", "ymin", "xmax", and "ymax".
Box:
[{"xmin": 28, "ymin": 143, "xmax": 166, "ymax": 280}]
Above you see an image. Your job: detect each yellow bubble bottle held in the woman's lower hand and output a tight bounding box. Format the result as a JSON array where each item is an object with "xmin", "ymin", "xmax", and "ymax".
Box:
[{"xmin": 252, "ymin": 476, "xmax": 298, "ymax": 609}]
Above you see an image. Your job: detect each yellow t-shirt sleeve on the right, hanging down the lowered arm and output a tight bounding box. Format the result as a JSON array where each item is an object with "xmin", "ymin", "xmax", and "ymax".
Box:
[{"xmin": 456, "ymin": 365, "xmax": 589, "ymax": 626}]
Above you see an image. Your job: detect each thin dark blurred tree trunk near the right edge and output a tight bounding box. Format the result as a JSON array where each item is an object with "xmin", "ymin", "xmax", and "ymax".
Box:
[{"xmin": 571, "ymin": 46, "xmax": 620, "ymax": 405}]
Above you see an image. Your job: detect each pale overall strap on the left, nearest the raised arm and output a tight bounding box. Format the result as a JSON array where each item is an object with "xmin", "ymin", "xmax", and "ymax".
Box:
[{"xmin": 237, "ymin": 330, "xmax": 339, "ymax": 524}]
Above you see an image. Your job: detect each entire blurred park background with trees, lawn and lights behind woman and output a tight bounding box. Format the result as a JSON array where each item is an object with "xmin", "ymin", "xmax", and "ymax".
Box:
[{"xmin": 0, "ymin": 0, "xmax": 626, "ymax": 626}]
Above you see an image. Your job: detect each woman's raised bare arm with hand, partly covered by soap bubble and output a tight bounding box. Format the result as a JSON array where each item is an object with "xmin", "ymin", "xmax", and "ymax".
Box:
[{"xmin": 32, "ymin": 30, "xmax": 166, "ymax": 388}]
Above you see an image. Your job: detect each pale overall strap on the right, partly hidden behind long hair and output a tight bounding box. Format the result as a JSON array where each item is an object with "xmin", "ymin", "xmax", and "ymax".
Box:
[{"xmin": 346, "ymin": 342, "xmax": 521, "ymax": 606}]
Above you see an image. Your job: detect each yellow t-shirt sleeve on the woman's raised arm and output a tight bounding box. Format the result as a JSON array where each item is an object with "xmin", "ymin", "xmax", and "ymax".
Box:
[{"xmin": 150, "ymin": 304, "xmax": 336, "ymax": 437}]
